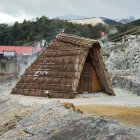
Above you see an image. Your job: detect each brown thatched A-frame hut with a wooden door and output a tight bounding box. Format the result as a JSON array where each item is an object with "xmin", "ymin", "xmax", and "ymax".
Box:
[{"xmin": 12, "ymin": 34, "xmax": 115, "ymax": 98}]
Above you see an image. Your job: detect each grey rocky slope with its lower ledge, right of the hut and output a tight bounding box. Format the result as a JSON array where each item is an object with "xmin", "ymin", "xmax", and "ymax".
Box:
[{"xmin": 102, "ymin": 39, "xmax": 140, "ymax": 96}]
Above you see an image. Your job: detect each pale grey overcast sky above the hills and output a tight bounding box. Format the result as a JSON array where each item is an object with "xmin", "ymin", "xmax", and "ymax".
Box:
[{"xmin": 0, "ymin": 0, "xmax": 140, "ymax": 23}]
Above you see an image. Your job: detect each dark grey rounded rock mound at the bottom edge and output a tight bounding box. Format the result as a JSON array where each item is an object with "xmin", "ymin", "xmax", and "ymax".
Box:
[{"xmin": 48, "ymin": 117, "xmax": 138, "ymax": 140}]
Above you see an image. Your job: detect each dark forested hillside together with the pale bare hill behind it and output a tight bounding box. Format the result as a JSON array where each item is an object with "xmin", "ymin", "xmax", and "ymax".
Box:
[{"xmin": 0, "ymin": 16, "xmax": 139, "ymax": 46}]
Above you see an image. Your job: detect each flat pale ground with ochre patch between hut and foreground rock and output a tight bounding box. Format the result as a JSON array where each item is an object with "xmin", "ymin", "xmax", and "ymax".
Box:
[{"xmin": 0, "ymin": 77, "xmax": 140, "ymax": 126}]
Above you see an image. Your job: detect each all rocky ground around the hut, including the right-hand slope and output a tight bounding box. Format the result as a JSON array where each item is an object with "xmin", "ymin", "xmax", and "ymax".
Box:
[{"xmin": 0, "ymin": 37, "xmax": 140, "ymax": 140}]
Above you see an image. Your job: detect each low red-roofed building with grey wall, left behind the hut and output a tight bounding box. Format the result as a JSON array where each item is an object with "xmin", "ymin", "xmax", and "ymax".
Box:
[{"xmin": 0, "ymin": 46, "xmax": 42, "ymax": 75}]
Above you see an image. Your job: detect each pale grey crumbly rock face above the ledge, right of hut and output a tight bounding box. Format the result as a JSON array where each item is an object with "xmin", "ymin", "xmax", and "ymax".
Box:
[{"xmin": 106, "ymin": 40, "xmax": 140, "ymax": 73}]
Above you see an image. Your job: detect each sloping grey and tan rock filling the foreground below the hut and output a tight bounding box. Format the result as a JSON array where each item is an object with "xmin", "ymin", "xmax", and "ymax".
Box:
[{"xmin": 0, "ymin": 96, "xmax": 140, "ymax": 140}]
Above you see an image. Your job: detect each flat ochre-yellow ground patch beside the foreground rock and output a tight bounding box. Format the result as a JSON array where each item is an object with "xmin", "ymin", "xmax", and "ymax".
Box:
[{"xmin": 77, "ymin": 105, "xmax": 140, "ymax": 126}]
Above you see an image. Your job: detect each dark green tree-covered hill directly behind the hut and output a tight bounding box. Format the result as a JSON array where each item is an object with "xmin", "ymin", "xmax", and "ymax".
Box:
[{"xmin": 0, "ymin": 16, "xmax": 108, "ymax": 45}]
